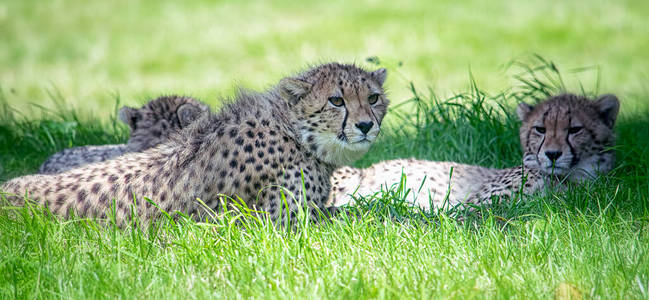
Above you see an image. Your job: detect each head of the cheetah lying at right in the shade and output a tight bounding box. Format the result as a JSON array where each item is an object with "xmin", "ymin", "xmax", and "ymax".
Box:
[{"xmin": 517, "ymin": 94, "xmax": 620, "ymax": 181}]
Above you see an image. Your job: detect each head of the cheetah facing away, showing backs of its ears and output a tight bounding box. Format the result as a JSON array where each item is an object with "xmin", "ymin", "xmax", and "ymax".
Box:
[{"xmin": 118, "ymin": 96, "xmax": 209, "ymax": 151}]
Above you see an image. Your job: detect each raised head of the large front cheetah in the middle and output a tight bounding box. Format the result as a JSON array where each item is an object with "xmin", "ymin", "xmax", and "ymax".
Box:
[{"xmin": 279, "ymin": 63, "xmax": 389, "ymax": 165}]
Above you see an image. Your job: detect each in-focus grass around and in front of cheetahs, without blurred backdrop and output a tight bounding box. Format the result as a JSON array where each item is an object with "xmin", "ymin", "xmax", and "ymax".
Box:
[{"xmin": 0, "ymin": 60, "xmax": 649, "ymax": 298}]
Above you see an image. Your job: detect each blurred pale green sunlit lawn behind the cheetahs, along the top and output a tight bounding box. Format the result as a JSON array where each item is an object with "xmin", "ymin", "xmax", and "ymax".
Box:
[{"xmin": 0, "ymin": 0, "xmax": 649, "ymax": 118}]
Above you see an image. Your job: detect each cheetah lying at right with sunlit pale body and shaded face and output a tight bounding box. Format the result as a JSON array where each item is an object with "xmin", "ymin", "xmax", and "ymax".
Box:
[{"xmin": 328, "ymin": 94, "xmax": 619, "ymax": 209}]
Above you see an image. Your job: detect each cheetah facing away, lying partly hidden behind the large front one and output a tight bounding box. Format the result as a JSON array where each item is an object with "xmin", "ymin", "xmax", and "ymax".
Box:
[{"xmin": 38, "ymin": 96, "xmax": 209, "ymax": 174}]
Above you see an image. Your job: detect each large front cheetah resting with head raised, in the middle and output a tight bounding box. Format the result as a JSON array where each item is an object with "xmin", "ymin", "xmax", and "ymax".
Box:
[{"xmin": 2, "ymin": 63, "xmax": 389, "ymax": 224}]
